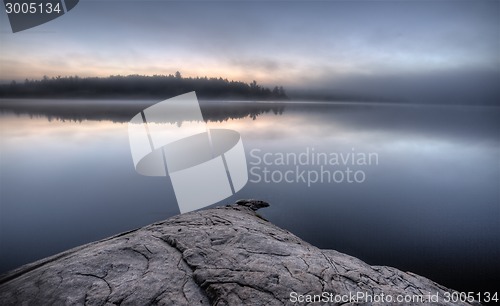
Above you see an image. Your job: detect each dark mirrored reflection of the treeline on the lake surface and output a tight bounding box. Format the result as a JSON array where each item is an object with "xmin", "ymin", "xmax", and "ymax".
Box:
[{"xmin": 0, "ymin": 99, "xmax": 285, "ymax": 124}]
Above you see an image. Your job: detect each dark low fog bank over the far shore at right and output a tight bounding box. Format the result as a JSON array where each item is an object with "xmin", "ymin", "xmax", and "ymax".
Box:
[{"xmin": 292, "ymin": 69, "xmax": 500, "ymax": 105}]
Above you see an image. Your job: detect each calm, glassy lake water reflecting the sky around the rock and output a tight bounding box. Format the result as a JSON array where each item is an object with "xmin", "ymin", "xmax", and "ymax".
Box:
[{"xmin": 0, "ymin": 101, "xmax": 500, "ymax": 291}]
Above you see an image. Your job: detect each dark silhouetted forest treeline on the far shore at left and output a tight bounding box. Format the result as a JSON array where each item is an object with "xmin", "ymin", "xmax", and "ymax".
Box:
[{"xmin": 0, "ymin": 71, "xmax": 288, "ymax": 100}]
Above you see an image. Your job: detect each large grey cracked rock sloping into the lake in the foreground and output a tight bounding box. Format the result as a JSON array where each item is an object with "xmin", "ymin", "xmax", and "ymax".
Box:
[{"xmin": 0, "ymin": 200, "xmax": 478, "ymax": 305}]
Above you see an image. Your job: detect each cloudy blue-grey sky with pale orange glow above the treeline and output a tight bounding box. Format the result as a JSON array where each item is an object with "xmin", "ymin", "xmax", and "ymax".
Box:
[{"xmin": 0, "ymin": 0, "xmax": 500, "ymax": 103}]
